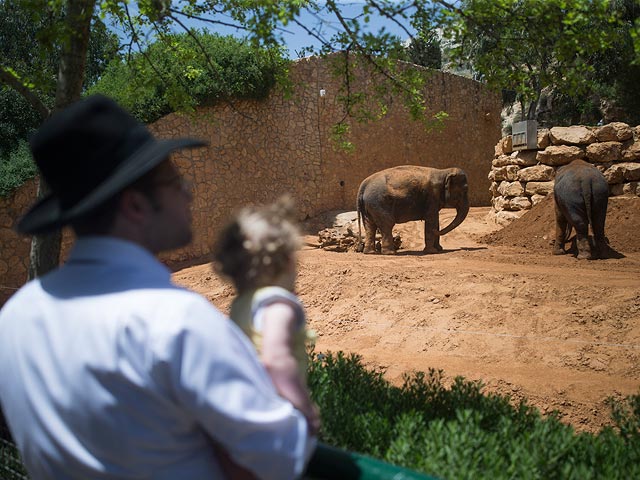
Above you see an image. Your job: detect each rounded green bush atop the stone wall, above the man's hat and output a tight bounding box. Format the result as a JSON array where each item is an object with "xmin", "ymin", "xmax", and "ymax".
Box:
[{"xmin": 88, "ymin": 31, "xmax": 289, "ymax": 123}]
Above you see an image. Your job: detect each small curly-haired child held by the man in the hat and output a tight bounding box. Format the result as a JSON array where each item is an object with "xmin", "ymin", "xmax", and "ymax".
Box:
[{"xmin": 214, "ymin": 197, "xmax": 320, "ymax": 435}]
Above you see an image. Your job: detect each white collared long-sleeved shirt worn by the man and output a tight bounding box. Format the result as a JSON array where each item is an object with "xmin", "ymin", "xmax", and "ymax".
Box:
[{"xmin": 0, "ymin": 237, "xmax": 313, "ymax": 479}]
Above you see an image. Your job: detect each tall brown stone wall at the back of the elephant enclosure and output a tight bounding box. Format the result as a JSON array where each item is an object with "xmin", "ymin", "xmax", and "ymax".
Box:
[{"xmin": 0, "ymin": 57, "xmax": 500, "ymax": 300}]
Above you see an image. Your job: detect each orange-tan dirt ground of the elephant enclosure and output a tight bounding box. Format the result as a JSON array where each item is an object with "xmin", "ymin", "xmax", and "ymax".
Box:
[{"xmin": 174, "ymin": 197, "xmax": 640, "ymax": 432}]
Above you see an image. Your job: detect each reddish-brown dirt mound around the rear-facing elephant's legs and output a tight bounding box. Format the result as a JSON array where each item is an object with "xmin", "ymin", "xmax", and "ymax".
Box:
[{"xmin": 481, "ymin": 195, "xmax": 640, "ymax": 254}]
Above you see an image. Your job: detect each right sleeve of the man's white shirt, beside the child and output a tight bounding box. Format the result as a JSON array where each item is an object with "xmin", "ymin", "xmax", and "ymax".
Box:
[{"xmin": 161, "ymin": 299, "xmax": 313, "ymax": 479}]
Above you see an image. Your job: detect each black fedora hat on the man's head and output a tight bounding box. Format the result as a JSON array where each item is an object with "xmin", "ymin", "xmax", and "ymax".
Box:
[{"xmin": 16, "ymin": 95, "xmax": 206, "ymax": 234}]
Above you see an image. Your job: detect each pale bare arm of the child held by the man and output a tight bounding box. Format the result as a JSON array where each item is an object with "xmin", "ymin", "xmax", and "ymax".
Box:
[{"xmin": 262, "ymin": 302, "xmax": 320, "ymax": 434}]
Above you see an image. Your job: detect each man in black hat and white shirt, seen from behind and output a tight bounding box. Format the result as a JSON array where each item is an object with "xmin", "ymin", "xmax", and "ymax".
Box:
[{"xmin": 0, "ymin": 96, "xmax": 313, "ymax": 479}]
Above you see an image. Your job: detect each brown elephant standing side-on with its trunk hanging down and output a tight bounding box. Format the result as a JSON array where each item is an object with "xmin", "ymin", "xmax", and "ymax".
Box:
[{"xmin": 356, "ymin": 165, "xmax": 469, "ymax": 255}]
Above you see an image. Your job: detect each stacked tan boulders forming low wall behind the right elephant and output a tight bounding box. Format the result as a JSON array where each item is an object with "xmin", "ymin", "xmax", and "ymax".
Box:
[{"xmin": 489, "ymin": 122, "xmax": 640, "ymax": 224}]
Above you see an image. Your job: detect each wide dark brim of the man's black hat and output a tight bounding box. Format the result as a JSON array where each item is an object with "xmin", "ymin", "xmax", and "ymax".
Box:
[{"xmin": 16, "ymin": 138, "xmax": 207, "ymax": 235}]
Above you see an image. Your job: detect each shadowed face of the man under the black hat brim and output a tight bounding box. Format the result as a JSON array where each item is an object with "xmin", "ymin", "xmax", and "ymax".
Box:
[{"xmin": 146, "ymin": 160, "xmax": 193, "ymax": 253}]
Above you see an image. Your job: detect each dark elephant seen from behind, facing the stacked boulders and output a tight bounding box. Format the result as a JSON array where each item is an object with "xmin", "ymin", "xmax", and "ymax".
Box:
[{"xmin": 553, "ymin": 160, "xmax": 609, "ymax": 259}]
